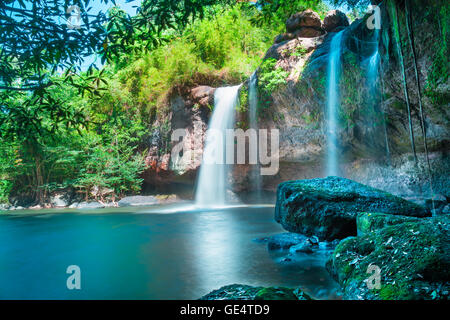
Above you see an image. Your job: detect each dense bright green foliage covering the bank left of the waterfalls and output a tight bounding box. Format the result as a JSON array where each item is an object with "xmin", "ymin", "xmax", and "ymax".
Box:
[{"xmin": 0, "ymin": 1, "xmax": 288, "ymax": 203}]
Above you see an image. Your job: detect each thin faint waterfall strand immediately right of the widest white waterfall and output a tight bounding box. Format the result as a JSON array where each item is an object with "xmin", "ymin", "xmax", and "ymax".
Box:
[{"xmin": 248, "ymin": 72, "xmax": 262, "ymax": 202}]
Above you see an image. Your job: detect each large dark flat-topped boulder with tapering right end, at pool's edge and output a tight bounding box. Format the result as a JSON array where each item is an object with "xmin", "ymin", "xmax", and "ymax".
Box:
[{"xmin": 275, "ymin": 177, "xmax": 431, "ymax": 240}]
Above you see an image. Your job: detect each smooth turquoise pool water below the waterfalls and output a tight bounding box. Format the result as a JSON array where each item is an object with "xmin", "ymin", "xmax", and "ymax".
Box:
[{"xmin": 0, "ymin": 207, "xmax": 336, "ymax": 299}]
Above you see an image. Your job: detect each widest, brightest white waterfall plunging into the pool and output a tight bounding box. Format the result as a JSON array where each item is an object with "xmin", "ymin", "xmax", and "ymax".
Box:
[{"xmin": 195, "ymin": 85, "xmax": 240, "ymax": 207}]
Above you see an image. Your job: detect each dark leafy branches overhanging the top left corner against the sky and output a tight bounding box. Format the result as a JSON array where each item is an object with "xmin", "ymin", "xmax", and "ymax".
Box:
[{"xmin": 0, "ymin": 0, "xmax": 231, "ymax": 124}]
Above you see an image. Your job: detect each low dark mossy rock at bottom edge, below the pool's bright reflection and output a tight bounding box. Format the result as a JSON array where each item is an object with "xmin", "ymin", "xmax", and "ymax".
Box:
[{"xmin": 200, "ymin": 284, "xmax": 312, "ymax": 300}]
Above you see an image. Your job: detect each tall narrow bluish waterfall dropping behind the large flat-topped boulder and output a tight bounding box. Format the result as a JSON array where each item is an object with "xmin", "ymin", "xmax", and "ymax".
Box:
[{"xmin": 327, "ymin": 31, "xmax": 344, "ymax": 176}]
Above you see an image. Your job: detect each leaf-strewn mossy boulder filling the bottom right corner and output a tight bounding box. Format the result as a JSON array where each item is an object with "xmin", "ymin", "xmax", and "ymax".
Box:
[{"xmin": 326, "ymin": 216, "xmax": 450, "ymax": 300}]
